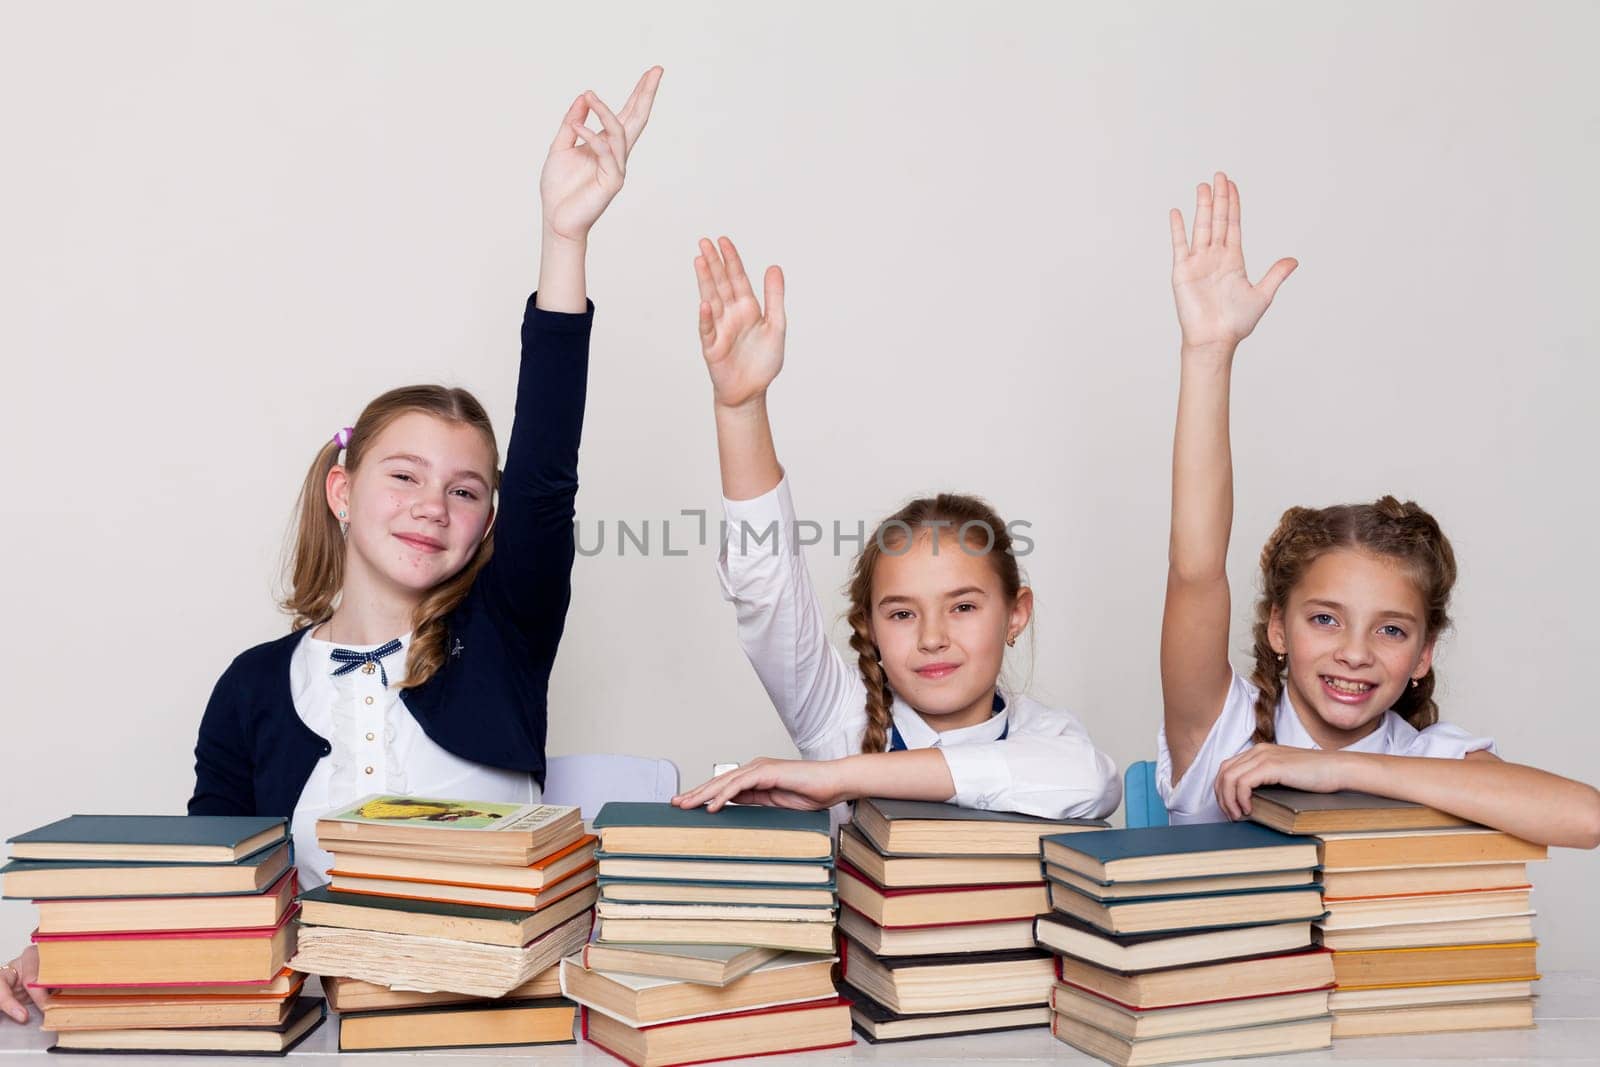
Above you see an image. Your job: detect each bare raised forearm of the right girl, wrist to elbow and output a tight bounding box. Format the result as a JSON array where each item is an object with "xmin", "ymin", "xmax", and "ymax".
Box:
[{"xmin": 1168, "ymin": 347, "xmax": 1234, "ymax": 581}]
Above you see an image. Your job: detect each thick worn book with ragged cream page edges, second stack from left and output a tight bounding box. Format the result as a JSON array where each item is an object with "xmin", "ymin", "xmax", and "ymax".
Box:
[{"xmin": 294, "ymin": 910, "xmax": 590, "ymax": 998}]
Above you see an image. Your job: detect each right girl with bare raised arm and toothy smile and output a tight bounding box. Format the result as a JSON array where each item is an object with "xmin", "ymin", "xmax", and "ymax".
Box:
[{"xmin": 1157, "ymin": 174, "xmax": 1600, "ymax": 848}]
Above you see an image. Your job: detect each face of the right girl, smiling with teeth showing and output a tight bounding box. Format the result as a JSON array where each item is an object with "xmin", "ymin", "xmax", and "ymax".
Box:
[{"xmin": 1267, "ymin": 549, "xmax": 1434, "ymax": 749}]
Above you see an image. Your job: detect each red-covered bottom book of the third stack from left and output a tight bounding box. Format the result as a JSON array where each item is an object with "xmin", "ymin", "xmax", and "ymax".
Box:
[{"xmin": 582, "ymin": 997, "xmax": 854, "ymax": 1067}]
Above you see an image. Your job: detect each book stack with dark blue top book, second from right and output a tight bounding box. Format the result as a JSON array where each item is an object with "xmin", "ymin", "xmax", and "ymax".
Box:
[{"xmin": 1037, "ymin": 822, "xmax": 1333, "ymax": 1065}]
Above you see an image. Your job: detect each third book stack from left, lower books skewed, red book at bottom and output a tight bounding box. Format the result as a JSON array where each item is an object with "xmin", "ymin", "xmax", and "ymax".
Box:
[{"xmin": 562, "ymin": 803, "xmax": 851, "ymax": 1067}]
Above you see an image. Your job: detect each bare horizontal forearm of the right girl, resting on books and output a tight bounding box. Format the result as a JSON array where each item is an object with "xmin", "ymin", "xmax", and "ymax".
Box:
[{"xmin": 1338, "ymin": 752, "xmax": 1600, "ymax": 848}]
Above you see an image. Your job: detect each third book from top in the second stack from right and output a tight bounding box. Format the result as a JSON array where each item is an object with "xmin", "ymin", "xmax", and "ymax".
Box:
[{"xmin": 1050, "ymin": 881, "xmax": 1323, "ymax": 934}]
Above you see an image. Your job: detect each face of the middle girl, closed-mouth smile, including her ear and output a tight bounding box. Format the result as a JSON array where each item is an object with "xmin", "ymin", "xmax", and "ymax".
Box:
[{"xmin": 867, "ymin": 531, "xmax": 1034, "ymax": 729}]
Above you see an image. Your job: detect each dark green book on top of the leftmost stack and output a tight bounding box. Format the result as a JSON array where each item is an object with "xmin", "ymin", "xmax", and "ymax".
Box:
[{"xmin": 6, "ymin": 816, "xmax": 288, "ymax": 864}]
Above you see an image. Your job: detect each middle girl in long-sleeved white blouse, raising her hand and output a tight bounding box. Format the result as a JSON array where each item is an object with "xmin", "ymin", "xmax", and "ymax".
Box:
[{"xmin": 674, "ymin": 238, "xmax": 1122, "ymax": 822}]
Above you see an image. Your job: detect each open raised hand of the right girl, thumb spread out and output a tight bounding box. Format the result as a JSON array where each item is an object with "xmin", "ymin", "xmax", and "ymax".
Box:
[{"xmin": 1170, "ymin": 171, "xmax": 1299, "ymax": 350}]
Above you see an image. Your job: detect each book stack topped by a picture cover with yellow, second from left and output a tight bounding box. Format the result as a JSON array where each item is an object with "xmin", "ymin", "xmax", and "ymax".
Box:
[{"xmin": 281, "ymin": 795, "xmax": 595, "ymax": 1051}]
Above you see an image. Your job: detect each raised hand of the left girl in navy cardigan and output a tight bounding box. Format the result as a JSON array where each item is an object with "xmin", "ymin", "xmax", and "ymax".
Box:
[{"xmin": 539, "ymin": 67, "xmax": 661, "ymax": 242}]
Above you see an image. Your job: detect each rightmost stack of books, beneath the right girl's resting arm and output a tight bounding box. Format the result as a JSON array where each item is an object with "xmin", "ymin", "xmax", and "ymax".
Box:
[{"xmin": 1251, "ymin": 787, "xmax": 1547, "ymax": 1037}]
